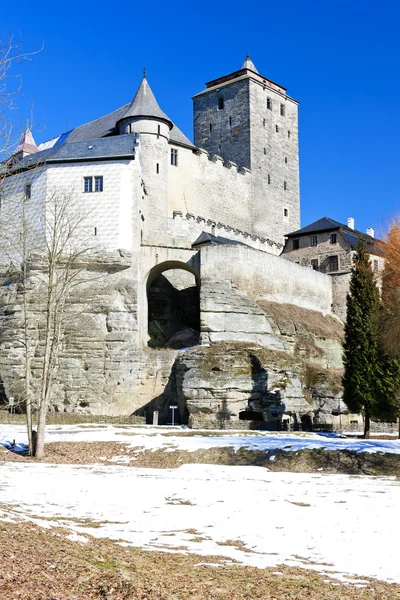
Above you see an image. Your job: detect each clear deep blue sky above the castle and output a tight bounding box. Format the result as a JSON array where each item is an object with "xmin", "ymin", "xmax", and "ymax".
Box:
[{"xmin": 1, "ymin": 0, "xmax": 400, "ymax": 234}]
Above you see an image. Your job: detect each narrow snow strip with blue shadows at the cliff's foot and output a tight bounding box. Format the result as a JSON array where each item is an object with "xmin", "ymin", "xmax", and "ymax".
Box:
[{"xmin": 0, "ymin": 425, "xmax": 400, "ymax": 454}]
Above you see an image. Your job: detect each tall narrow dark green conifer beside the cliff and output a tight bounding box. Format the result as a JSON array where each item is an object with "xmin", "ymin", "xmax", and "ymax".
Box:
[{"xmin": 343, "ymin": 240, "xmax": 384, "ymax": 438}]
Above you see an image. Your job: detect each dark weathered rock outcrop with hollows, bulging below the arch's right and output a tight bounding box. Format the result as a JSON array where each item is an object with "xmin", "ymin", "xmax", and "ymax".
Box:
[{"xmin": 150, "ymin": 342, "xmax": 361, "ymax": 430}]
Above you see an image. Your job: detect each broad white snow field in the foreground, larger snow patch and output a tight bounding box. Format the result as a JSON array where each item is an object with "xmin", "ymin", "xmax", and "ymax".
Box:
[{"xmin": 0, "ymin": 463, "xmax": 400, "ymax": 583}]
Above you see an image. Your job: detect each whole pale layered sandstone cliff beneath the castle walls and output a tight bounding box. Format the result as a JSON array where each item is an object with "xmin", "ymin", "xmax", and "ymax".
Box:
[{"xmin": 0, "ymin": 251, "xmax": 350, "ymax": 429}]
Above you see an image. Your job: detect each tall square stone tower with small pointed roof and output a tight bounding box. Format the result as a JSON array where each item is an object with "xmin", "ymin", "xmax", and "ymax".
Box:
[{"xmin": 193, "ymin": 56, "xmax": 300, "ymax": 243}]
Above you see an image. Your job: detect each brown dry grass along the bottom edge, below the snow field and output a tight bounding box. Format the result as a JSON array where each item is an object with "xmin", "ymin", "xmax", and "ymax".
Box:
[{"xmin": 0, "ymin": 521, "xmax": 400, "ymax": 600}]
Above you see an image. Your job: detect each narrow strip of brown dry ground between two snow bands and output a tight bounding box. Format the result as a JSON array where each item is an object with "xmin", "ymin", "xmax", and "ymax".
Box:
[{"xmin": 0, "ymin": 442, "xmax": 400, "ymax": 477}]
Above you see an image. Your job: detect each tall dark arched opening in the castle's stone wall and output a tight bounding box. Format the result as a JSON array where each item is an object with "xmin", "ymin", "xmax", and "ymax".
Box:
[{"xmin": 146, "ymin": 261, "xmax": 200, "ymax": 349}]
